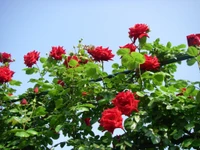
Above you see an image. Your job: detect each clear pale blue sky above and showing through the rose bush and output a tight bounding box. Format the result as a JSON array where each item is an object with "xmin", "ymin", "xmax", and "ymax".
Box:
[{"xmin": 0, "ymin": 0, "xmax": 200, "ymax": 150}]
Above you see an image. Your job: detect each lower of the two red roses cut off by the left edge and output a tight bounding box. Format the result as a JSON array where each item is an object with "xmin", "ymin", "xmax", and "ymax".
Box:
[{"xmin": 0, "ymin": 66, "xmax": 15, "ymax": 83}]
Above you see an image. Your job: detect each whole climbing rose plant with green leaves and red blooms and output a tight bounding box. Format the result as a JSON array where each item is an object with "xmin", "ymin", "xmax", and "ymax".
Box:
[{"xmin": 0, "ymin": 24, "xmax": 200, "ymax": 150}]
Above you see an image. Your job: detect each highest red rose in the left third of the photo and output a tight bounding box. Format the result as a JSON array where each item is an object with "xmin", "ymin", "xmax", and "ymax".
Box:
[{"xmin": 50, "ymin": 46, "xmax": 66, "ymax": 60}]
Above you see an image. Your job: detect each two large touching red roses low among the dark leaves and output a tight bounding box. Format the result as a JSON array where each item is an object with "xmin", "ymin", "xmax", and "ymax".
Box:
[{"xmin": 100, "ymin": 91, "xmax": 139, "ymax": 133}]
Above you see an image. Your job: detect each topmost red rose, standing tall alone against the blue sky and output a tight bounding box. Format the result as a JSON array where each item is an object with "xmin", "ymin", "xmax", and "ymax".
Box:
[{"xmin": 128, "ymin": 24, "xmax": 150, "ymax": 43}]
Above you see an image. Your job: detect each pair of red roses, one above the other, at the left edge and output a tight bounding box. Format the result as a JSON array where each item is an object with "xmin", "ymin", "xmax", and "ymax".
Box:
[{"xmin": 0, "ymin": 52, "xmax": 14, "ymax": 84}]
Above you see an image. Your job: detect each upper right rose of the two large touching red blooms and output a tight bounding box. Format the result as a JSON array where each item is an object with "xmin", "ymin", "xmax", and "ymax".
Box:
[{"xmin": 112, "ymin": 91, "xmax": 139, "ymax": 116}]
